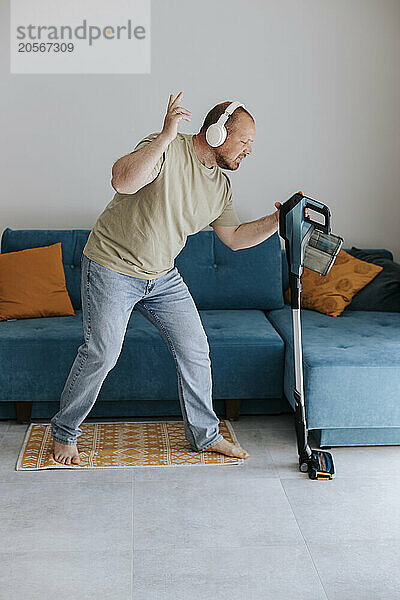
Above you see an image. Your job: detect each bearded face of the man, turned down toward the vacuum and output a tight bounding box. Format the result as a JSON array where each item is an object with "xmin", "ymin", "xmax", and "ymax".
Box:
[{"xmin": 215, "ymin": 115, "xmax": 256, "ymax": 171}]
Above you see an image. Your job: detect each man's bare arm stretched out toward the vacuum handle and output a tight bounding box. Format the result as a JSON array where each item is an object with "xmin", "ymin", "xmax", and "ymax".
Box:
[{"xmin": 211, "ymin": 210, "xmax": 279, "ymax": 250}]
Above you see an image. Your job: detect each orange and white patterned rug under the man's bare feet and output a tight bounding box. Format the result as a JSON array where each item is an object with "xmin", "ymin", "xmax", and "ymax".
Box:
[{"xmin": 15, "ymin": 420, "xmax": 244, "ymax": 471}]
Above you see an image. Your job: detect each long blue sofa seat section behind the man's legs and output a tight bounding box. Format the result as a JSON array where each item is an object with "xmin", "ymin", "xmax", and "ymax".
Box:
[{"xmin": 0, "ymin": 309, "xmax": 284, "ymax": 401}]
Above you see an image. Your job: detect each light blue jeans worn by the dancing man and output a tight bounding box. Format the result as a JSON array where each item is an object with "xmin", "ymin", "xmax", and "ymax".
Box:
[{"xmin": 51, "ymin": 254, "xmax": 223, "ymax": 452}]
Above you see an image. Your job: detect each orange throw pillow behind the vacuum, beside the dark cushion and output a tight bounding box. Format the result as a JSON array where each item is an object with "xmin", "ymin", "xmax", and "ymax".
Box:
[{"xmin": 284, "ymin": 250, "xmax": 383, "ymax": 317}]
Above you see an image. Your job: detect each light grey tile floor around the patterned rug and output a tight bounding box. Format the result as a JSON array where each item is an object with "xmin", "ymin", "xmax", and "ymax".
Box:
[{"xmin": 0, "ymin": 415, "xmax": 400, "ymax": 600}]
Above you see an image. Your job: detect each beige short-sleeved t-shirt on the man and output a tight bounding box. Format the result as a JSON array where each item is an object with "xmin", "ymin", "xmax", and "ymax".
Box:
[{"xmin": 83, "ymin": 133, "xmax": 240, "ymax": 279}]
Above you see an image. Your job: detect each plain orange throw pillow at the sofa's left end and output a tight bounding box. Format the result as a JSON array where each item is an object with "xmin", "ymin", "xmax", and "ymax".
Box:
[{"xmin": 0, "ymin": 242, "xmax": 75, "ymax": 321}]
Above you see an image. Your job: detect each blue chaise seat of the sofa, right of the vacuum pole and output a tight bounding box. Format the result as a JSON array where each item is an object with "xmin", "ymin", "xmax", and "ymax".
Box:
[{"xmin": 266, "ymin": 306, "xmax": 400, "ymax": 429}]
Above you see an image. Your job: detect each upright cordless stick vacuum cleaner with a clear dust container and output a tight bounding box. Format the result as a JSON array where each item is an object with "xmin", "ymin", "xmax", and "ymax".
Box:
[{"xmin": 279, "ymin": 193, "xmax": 343, "ymax": 480}]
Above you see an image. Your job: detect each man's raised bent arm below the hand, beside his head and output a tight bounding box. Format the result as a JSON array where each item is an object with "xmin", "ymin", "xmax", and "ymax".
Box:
[{"xmin": 111, "ymin": 132, "xmax": 171, "ymax": 194}]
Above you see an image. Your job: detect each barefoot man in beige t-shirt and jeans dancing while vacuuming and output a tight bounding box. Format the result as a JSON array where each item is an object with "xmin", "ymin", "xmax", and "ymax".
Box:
[{"xmin": 51, "ymin": 92, "xmax": 280, "ymax": 464}]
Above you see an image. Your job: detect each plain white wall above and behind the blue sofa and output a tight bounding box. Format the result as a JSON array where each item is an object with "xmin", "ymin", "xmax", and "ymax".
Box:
[{"xmin": 0, "ymin": 0, "xmax": 400, "ymax": 261}]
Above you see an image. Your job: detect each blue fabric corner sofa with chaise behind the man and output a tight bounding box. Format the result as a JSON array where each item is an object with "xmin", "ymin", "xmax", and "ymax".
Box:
[{"xmin": 0, "ymin": 228, "xmax": 400, "ymax": 447}]
